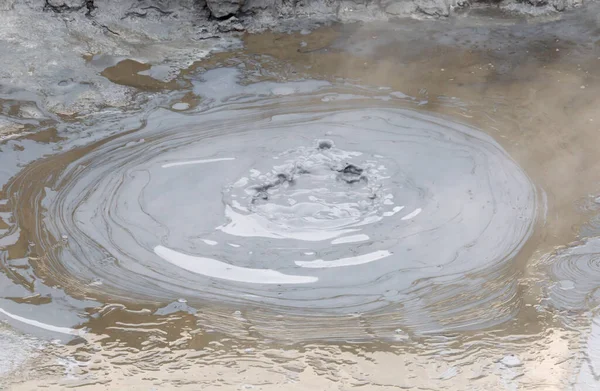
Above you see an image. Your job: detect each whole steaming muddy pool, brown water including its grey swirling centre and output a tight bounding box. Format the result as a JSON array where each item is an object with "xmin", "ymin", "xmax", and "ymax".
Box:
[{"xmin": 0, "ymin": 8, "xmax": 600, "ymax": 390}]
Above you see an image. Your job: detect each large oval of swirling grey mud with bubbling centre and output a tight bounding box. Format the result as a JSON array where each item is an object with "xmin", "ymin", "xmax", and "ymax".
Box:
[{"xmin": 5, "ymin": 72, "xmax": 536, "ymax": 338}]
